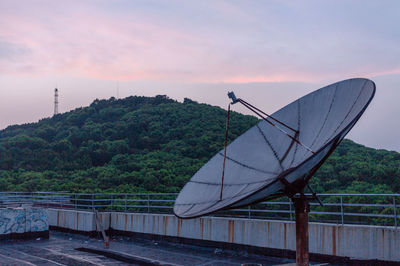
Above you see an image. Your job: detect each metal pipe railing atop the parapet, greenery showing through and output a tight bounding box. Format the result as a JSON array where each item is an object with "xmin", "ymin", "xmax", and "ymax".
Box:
[{"xmin": 0, "ymin": 192, "xmax": 400, "ymax": 227}]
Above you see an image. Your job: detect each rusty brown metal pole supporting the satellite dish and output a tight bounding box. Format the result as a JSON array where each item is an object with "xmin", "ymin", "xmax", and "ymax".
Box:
[{"xmin": 293, "ymin": 196, "xmax": 310, "ymax": 266}]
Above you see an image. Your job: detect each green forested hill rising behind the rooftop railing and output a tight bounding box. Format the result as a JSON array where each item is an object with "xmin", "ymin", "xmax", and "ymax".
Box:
[{"xmin": 0, "ymin": 96, "xmax": 400, "ymax": 192}]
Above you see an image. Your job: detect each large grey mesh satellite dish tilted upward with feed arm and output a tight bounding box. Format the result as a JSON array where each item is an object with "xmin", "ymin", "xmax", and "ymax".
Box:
[{"xmin": 174, "ymin": 78, "xmax": 375, "ymax": 218}]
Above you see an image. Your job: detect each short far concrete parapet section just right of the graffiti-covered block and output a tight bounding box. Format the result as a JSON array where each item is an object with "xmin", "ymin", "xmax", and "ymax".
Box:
[{"xmin": 47, "ymin": 209, "xmax": 110, "ymax": 232}]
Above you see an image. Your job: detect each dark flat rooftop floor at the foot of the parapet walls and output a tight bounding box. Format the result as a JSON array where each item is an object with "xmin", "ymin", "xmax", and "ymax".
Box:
[{"xmin": 0, "ymin": 231, "xmax": 310, "ymax": 265}]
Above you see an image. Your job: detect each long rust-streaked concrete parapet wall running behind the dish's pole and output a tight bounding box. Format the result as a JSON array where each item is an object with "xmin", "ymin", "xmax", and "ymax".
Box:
[{"xmin": 111, "ymin": 213, "xmax": 400, "ymax": 261}]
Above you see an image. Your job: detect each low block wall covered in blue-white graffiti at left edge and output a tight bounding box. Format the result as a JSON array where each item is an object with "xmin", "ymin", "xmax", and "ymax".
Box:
[{"xmin": 0, "ymin": 208, "xmax": 49, "ymax": 236}]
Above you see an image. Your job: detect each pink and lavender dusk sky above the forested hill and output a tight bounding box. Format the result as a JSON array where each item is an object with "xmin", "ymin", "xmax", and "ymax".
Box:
[{"xmin": 0, "ymin": 0, "xmax": 400, "ymax": 151}]
